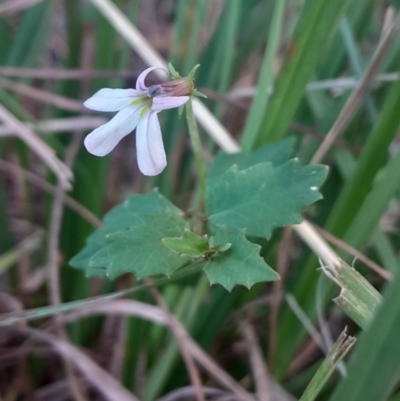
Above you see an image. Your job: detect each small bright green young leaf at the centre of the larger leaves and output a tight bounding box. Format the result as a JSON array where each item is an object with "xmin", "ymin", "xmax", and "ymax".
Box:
[{"xmin": 162, "ymin": 230, "xmax": 210, "ymax": 258}]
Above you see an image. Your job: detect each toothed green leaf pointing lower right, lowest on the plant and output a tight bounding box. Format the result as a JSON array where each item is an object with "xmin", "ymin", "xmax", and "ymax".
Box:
[{"xmin": 204, "ymin": 227, "xmax": 279, "ymax": 291}]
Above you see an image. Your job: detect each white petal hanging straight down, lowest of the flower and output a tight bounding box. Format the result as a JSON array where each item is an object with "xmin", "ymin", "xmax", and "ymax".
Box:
[{"xmin": 136, "ymin": 112, "xmax": 167, "ymax": 176}]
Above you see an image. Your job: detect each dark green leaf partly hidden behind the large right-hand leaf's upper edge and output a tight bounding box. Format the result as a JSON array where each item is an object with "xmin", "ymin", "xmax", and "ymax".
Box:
[{"xmin": 209, "ymin": 137, "xmax": 295, "ymax": 177}]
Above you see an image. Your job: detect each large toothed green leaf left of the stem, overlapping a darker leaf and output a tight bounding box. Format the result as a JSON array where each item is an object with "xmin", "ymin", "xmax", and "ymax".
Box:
[{"xmin": 89, "ymin": 209, "xmax": 190, "ymax": 279}]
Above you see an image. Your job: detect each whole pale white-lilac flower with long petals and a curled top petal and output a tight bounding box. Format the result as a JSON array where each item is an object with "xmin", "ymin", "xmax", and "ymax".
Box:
[{"xmin": 84, "ymin": 67, "xmax": 193, "ymax": 176}]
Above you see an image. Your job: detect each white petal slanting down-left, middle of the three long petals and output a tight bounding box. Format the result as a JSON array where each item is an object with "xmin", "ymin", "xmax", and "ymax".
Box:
[{"xmin": 84, "ymin": 107, "xmax": 141, "ymax": 156}]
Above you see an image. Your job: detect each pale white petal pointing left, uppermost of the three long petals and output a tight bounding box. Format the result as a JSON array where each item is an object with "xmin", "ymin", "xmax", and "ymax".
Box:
[{"xmin": 83, "ymin": 88, "xmax": 143, "ymax": 111}]
